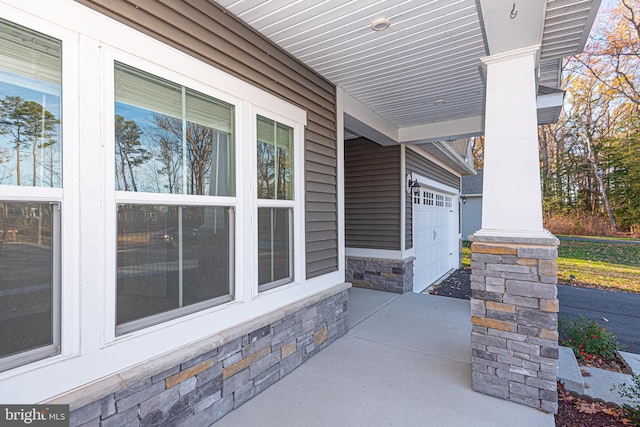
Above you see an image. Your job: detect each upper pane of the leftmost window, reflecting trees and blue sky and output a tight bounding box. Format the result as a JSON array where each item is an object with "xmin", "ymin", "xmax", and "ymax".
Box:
[{"xmin": 0, "ymin": 20, "xmax": 62, "ymax": 187}]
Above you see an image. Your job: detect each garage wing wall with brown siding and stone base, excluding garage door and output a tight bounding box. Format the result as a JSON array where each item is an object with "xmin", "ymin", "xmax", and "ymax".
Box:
[{"xmin": 345, "ymin": 142, "xmax": 460, "ymax": 293}]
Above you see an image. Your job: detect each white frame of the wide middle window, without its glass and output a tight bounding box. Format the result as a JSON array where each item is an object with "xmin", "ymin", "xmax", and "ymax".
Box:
[{"xmin": 100, "ymin": 46, "xmax": 245, "ymax": 346}]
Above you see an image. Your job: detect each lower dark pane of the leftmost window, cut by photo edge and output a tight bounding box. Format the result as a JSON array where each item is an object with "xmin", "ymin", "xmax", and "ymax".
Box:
[{"xmin": 0, "ymin": 202, "xmax": 54, "ymax": 358}]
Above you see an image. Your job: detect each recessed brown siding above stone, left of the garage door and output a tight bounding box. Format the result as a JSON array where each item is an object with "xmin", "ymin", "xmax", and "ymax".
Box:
[{"xmin": 344, "ymin": 138, "xmax": 401, "ymax": 250}]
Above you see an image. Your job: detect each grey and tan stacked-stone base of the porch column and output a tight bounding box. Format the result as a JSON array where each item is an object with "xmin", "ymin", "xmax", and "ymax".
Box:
[{"xmin": 471, "ymin": 234, "xmax": 559, "ymax": 413}]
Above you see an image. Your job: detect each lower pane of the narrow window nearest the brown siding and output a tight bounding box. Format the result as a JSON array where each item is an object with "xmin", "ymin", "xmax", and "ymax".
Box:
[{"xmin": 258, "ymin": 208, "xmax": 292, "ymax": 285}]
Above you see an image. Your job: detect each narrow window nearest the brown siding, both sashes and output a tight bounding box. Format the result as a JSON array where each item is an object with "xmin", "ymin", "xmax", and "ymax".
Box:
[{"xmin": 257, "ymin": 116, "xmax": 294, "ymax": 290}]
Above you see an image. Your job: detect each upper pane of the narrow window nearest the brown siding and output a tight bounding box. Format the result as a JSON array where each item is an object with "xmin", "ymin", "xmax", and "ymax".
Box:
[{"xmin": 257, "ymin": 116, "xmax": 294, "ymax": 200}]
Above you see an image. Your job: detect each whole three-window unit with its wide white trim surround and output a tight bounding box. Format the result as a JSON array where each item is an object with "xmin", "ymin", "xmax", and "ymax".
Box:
[{"xmin": 0, "ymin": 0, "xmax": 312, "ymax": 384}]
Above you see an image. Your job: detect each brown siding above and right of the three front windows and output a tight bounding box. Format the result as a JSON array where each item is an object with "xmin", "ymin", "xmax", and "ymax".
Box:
[{"xmin": 76, "ymin": 0, "xmax": 338, "ymax": 278}]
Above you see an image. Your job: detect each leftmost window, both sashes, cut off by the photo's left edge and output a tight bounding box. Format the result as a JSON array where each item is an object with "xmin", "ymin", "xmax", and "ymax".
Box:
[{"xmin": 0, "ymin": 20, "xmax": 62, "ymax": 370}]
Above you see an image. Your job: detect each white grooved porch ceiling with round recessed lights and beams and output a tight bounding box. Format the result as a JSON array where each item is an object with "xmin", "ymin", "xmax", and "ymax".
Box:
[{"xmin": 210, "ymin": 0, "xmax": 600, "ymax": 143}]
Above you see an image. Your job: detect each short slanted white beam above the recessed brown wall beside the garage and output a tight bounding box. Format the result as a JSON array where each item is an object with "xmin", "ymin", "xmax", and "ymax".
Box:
[{"xmin": 342, "ymin": 91, "xmax": 398, "ymax": 145}]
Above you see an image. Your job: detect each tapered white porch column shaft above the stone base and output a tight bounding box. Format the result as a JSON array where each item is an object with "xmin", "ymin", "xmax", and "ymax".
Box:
[{"xmin": 477, "ymin": 46, "xmax": 548, "ymax": 237}]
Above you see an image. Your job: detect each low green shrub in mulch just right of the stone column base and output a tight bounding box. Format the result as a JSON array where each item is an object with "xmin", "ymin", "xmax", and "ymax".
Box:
[{"xmin": 558, "ymin": 316, "xmax": 621, "ymax": 362}]
